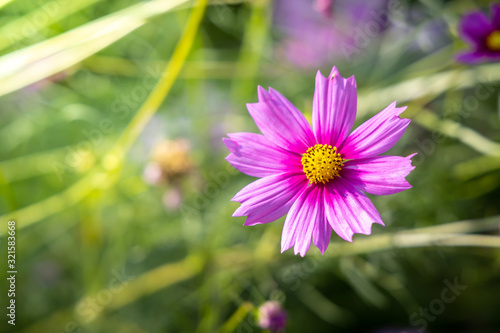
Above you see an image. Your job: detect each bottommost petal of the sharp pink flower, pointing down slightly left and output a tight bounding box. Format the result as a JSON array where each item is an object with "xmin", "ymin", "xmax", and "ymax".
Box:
[{"xmin": 281, "ymin": 186, "xmax": 331, "ymax": 257}]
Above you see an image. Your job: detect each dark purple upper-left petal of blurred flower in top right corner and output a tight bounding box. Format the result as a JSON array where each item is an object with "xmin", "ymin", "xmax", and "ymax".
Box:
[{"xmin": 459, "ymin": 11, "xmax": 493, "ymax": 48}]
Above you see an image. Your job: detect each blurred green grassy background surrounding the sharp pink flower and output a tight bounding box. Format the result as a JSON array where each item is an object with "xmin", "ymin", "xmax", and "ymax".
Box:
[{"xmin": 0, "ymin": 0, "xmax": 500, "ymax": 333}]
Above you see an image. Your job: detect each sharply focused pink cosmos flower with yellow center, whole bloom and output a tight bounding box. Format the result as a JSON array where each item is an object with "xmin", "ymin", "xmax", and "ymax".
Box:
[{"xmin": 223, "ymin": 67, "xmax": 414, "ymax": 256}]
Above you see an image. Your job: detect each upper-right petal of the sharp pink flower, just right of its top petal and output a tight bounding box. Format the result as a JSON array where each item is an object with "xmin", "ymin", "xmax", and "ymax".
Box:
[{"xmin": 339, "ymin": 102, "xmax": 410, "ymax": 159}]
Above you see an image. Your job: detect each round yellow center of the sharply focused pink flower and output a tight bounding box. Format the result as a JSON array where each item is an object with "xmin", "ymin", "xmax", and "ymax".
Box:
[{"xmin": 301, "ymin": 144, "xmax": 345, "ymax": 184}]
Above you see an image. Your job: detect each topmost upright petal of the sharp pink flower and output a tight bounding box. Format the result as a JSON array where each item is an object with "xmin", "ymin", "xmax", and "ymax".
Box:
[{"xmin": 313, "ymin": 67, "xmax": 357, "ymax": 147}]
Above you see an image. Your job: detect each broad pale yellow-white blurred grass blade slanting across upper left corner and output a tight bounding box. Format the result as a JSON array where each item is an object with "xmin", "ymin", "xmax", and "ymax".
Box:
[{"xmin": 0, "ymin": 0, "xmax": 187, "ymax": 96}]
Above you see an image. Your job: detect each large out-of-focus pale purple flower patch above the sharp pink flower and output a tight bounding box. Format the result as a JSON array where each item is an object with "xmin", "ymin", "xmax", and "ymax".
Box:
[{"xmin": 274, "ymin": 0, "xmax": 390, "ymax": 68}]
